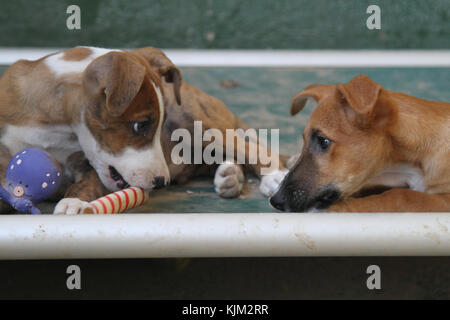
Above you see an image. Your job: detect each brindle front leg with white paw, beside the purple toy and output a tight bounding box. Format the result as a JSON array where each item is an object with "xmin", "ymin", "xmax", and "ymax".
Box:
[{"xmin": 53, "ymin": 152, "xmax": 109, "ymax": 215}]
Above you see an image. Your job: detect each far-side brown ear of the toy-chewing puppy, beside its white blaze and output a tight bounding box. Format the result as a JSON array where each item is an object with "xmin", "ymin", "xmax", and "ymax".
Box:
[{"xmin": 134, "ymin": 47, "xmax": 183, "ymax": 105}]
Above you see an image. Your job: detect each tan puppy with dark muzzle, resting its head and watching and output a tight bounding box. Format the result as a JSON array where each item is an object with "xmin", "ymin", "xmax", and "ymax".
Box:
[{"xmin": 270, "ymin": 75, "xmax": 450, "ymax": 212}]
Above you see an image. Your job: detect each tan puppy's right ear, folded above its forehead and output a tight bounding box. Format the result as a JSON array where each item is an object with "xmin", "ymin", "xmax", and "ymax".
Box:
[{"xmin": 337, "ymin": 74, "xmax": 393, "ymax": 128}]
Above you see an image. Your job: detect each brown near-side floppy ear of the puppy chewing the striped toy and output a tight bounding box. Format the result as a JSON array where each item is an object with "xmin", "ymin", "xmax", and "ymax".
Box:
[{"xmin": 83, "ymin": 52, "xmax": 145, "ymax": 117}]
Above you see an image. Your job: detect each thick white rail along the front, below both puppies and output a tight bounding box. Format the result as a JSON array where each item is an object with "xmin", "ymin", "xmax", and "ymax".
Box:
[{"xmin": 0, "ymin": 213, "xmax": 450, "ymax": 259}]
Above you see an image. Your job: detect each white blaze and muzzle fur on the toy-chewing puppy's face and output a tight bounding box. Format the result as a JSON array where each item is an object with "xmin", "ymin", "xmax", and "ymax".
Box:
[{"xmin": 74, "ymin": 83, "xmax": 170, "ymax": 191}]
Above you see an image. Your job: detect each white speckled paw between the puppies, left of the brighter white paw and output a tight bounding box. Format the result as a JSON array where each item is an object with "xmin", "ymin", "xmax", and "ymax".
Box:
[{"xmin": 214, "ymin": 161, "xmax": 244, "ymax": 198}]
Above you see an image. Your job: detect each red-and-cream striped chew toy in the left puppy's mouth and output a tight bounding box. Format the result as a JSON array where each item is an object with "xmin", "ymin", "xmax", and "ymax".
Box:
[{"xmin": 83, "ymin": 187, "xmax": 148, "ymax": 214}]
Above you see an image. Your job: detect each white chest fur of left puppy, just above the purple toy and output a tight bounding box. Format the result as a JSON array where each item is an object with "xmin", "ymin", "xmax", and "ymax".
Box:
[{"xmin": 0, "ymin": 125, "xmax": 81, "ymax": 164}]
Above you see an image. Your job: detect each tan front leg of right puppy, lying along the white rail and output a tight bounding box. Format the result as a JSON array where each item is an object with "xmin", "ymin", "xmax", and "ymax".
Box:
[{"xmin": 326, "ymin": 189, "xmax": 450, "ymax": 212}]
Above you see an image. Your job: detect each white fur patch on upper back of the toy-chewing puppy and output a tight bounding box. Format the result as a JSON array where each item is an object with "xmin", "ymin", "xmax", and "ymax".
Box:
[{"xmin": 44, "ymin": 47, "xmax": 120, "ymax": 77}]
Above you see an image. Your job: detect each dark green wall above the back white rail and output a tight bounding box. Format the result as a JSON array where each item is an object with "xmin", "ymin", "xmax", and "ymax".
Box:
[{"xmin": 0, "ymin": 0, "xmax": 450, "ymax": 49}]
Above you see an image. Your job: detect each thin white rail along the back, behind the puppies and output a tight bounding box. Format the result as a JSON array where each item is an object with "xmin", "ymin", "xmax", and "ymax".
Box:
[{"xmin": 0, "ymin": 48, "xmax": 450, "ymax": 67}]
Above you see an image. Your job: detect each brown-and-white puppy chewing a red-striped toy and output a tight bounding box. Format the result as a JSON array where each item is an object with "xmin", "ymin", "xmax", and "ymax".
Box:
[{"xmin": 0, "ymin": 47, "xmax": 283, "ymax": 214}]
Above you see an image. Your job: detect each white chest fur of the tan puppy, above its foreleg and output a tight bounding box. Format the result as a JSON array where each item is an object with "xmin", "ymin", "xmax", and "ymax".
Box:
[{"xmin": 364, "ymin": 163, "xmax": 425, "ymax": 192}]
